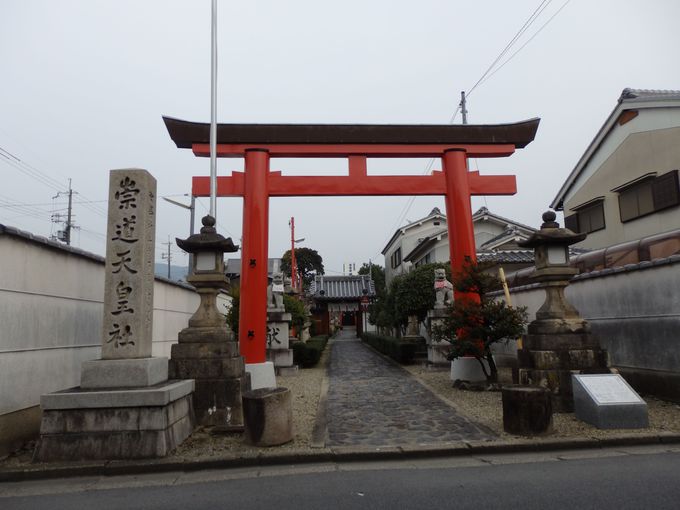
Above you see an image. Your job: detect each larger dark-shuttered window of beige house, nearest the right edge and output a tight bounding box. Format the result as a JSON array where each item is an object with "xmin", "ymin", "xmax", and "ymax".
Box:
[{"xmin": 613, "ymin": 170, "xmax": 680, "ymax": 222}]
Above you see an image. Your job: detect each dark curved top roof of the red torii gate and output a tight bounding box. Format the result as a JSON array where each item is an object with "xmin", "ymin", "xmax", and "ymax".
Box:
[{"xmin": 163, "ymin": 117, "xmax": 540, "ymax": 149}]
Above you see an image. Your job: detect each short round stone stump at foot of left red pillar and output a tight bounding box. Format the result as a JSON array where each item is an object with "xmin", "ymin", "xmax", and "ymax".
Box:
[{"xmin": 243, "ymin": 388, "xmax": 293, "ymax": 446}]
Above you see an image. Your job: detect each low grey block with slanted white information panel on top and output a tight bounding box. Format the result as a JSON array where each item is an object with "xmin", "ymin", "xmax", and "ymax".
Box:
[{"xmin": 572, "ymin": 374, "xmax": 649, "ymax": 429}]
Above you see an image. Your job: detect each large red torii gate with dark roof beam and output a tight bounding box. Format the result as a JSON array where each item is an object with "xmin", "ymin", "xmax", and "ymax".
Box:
[{"xmin": 163, "ymin": 117, "xmax": 539, "ymax": 364}]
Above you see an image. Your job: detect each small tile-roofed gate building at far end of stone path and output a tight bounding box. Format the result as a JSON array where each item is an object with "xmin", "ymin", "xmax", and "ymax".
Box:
[{"xmin": 309, "ymin": 275, "xmax": 376, "ymax": 334}]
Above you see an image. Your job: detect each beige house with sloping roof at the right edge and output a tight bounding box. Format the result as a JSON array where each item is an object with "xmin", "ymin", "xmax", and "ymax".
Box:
[{"xmin": 551, "ymin": 89, "xmax": 680, "ymax": 249}]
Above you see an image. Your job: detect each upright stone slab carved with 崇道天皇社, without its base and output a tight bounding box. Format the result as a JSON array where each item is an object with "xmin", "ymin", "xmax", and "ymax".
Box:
[{"xmin": 102, "ymin": 169, "xmax": 156, "ymax": 359}]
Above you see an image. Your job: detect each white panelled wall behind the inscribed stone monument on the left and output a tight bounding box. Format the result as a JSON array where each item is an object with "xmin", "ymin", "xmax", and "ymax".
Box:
[{"xmin": 0, "ymin": 226, "xmax": 199, "ymax": 418}]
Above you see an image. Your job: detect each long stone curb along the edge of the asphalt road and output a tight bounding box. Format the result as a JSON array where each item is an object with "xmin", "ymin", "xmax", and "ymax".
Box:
[{"xmin": 0, "ymin": 432, "xmax": 680, "ymax": 482}]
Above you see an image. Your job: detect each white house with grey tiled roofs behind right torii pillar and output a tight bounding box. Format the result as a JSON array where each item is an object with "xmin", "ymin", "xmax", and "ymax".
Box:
[{"xmin": 382, "ymin": 207, "xmax": 535, "ymax": 283}]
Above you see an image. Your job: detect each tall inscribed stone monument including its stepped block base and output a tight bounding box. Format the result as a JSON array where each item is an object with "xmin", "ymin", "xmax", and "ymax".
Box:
[{"xmin": 35, "ymin": 169, "xmax": 194, "ymax": 462}]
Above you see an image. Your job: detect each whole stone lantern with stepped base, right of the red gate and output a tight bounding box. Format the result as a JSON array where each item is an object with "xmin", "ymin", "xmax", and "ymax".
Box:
[{"xmin": 517, "ymin": 211, "xmax": 609, "ymax": 412}]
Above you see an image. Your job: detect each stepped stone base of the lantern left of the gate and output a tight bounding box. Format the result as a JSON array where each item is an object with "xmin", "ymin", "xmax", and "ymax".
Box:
[{"xmin": 169, "ymin": 327, "xmax": 250, "ymax": 432}]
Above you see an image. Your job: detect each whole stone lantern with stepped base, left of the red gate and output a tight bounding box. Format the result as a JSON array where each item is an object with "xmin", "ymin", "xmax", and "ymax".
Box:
[{"xmin": 169, "ymin": 216, "xmax": 250, "ymax": 431}]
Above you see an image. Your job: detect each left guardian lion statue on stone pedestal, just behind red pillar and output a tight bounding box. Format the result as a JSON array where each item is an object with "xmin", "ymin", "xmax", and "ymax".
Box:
[{"xmin": 267, "ymin": 273, "xmax": 293, "ymax": 371}]
